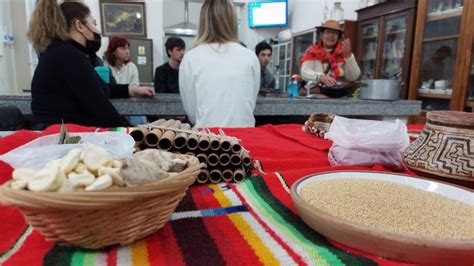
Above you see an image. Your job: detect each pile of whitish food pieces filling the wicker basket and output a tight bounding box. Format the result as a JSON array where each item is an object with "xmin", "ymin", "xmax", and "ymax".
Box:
[{"xmin": 11, "ymin": 145, "xmax": 187, "ymax": 192}]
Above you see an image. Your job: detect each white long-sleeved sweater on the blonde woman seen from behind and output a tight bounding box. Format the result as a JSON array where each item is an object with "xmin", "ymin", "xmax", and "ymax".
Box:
[{"xmin": 179, "ymin": 42, "xmax": 260, "ymax": 127}]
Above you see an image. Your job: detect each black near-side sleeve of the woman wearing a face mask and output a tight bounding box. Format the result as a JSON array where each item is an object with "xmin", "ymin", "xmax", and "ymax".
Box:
[{"xmin": 62, "ymin": 52, "xmax": 125, "ymax": 127}]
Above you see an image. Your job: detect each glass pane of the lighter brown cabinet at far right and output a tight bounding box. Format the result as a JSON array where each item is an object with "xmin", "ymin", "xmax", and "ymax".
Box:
[{"xmin": 418, "ymin": 0, "xmax": 464, "ymax": 111}]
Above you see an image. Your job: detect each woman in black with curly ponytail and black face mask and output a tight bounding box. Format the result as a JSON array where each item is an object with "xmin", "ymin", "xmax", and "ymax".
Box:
[{"xmin": 28, "ymin": 0, "xmax": 154, "ymax": 129}]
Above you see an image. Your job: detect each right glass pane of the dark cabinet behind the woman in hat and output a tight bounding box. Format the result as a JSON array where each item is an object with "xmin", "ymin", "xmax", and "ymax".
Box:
[{"xmin": 381, "ymin": 16, "xmax": 407, "ymax": 80}]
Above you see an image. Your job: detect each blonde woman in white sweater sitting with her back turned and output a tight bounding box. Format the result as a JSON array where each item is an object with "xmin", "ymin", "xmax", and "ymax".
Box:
[{"xmin": 179, "ymin": 0, "xmax": 260, "ymax": 127}]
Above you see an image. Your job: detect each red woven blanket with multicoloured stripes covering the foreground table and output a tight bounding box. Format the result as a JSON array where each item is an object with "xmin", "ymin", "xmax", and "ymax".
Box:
[{"xmin": 0, "ymin": 125, "xmax": 418, "ymax": 265}]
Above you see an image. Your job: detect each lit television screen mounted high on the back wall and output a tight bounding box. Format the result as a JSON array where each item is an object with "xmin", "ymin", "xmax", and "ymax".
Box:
[{"xmin": 248, "ymin": 0, "xmax": 288, "ymax": 28}]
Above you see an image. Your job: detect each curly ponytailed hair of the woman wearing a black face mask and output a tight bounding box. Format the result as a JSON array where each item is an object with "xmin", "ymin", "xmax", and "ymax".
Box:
[{"xmin": 27, "ymin": 0, "xmax": 90, "ymax": 53}]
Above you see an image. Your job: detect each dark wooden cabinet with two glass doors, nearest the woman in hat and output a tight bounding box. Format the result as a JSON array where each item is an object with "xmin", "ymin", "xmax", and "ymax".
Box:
[{"xmin": 356, "ymin": 0, "xmax": 416, "ymax": 99}]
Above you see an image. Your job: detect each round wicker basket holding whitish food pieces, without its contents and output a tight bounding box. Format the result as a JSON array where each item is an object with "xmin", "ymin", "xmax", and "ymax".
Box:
[{"xmin": 0, "ymin": 156, "xmax": 203, "ymax": 249}]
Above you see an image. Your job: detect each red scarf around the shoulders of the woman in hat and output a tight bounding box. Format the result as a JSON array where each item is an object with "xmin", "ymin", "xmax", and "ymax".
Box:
[{"xmin": 301, "ymin": 41, "xmax": 346, "ymax": 78}]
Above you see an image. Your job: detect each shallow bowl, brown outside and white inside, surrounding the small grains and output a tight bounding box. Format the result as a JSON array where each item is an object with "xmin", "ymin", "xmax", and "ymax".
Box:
[{"xmin": 291, "ymin": 171, "xmax": 474, "ymax": 265}]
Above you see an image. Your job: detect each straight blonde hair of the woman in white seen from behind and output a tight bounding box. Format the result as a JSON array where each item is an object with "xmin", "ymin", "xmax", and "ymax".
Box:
[{"xmin": 194, "ymin": 0, "xmax": 238, "ymax": 46}]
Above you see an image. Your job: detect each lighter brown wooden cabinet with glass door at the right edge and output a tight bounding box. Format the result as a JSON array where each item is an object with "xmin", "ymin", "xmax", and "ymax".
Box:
[{"xmin": 409, "ymin": 0, "xmax": 474, "ymax": 114}]
